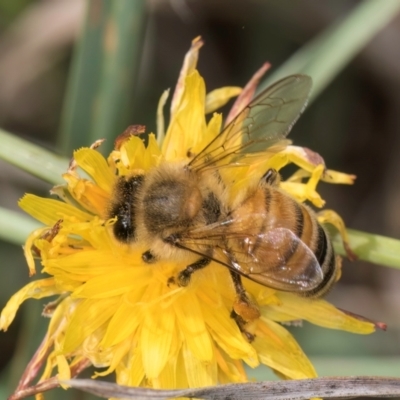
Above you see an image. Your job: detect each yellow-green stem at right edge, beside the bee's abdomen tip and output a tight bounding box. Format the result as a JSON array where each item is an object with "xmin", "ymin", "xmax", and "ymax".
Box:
[{"xmin": 333, "ymin": 229, "xmax": 400, "ymax": 269}]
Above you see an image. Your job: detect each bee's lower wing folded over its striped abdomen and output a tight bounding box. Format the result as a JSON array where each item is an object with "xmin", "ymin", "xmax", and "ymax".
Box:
[{"xmin": 179, "ymin": 222, "xmax": 324, "ymax": 292}]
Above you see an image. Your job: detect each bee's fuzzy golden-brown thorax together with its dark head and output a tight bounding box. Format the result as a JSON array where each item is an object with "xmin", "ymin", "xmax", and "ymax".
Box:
[{"xmin": 109, "ymin": 163, "xmax": 227, "ymax": 260}]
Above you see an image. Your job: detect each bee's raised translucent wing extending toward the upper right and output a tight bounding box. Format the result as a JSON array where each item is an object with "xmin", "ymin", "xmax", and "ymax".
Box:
[{"xmin": 189, "ymin": 75, "xmax": 312, "ymax": 171}]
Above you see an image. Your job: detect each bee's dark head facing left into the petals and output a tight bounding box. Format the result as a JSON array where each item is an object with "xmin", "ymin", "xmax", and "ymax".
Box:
[{"xmin": 108, "ymin": 175, "xmax": 144, "ymax": 243}]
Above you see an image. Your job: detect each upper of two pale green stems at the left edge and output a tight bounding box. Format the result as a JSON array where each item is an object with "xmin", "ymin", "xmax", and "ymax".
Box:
[{"xmin": 0, "ymin": 129, "xmax": 68, "ymax": 184}]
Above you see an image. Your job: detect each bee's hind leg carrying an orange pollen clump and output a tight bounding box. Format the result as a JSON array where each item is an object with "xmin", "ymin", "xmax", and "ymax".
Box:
[{"xmin": 229, "ymin": 270, "xmax": 260, "ymax": 342}]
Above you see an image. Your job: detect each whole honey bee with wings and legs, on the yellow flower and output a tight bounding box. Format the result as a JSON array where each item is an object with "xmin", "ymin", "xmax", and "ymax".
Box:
[{"xmin": 108, "ymin": 75, "xmax": 338, "ymax": 339}]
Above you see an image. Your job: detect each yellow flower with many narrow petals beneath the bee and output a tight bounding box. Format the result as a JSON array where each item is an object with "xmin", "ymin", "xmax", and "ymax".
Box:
[{"xmin": 0, "ymin": 39, "xmax": 374, "ymax": 396}]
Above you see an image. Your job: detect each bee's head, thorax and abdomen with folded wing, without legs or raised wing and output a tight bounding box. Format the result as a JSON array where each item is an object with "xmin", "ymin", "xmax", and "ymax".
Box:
[{"xmin": 109, "ymin": 159, "xmax": 337, "ymax": 297}]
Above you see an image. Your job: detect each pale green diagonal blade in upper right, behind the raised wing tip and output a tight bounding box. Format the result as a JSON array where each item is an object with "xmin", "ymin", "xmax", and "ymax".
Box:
[{"xmin": 259, "ymin": 0, "xmax": 400, "ymax": 101}]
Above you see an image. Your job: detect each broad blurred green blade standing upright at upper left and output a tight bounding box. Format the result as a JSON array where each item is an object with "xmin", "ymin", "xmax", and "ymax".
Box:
[{"xmin": 60, "ymin": 0, "xmax": 145, "ymax": 154}]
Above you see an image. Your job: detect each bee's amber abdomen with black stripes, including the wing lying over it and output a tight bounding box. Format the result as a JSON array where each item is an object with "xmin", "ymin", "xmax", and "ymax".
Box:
[{"xmin": 227, "ymin": 184, "xmax": 337, "ymax": 297}]
